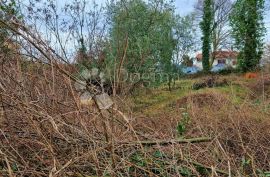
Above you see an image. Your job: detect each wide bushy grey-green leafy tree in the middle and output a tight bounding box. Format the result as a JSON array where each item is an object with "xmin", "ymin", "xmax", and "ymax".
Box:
[{"xmin": 106, "ymin": 0, "xmax": 176, "ymax": 91}]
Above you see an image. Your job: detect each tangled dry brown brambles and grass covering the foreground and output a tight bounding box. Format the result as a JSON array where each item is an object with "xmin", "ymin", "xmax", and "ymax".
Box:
[{"xmin": 0, "ymin": 56, "xmax": 270, "ymax": 177}]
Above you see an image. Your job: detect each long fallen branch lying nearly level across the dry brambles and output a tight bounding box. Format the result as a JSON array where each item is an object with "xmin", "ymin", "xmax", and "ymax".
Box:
[{"xmin": 124, "ymin": 137, "xmax": 212, "ymax": 146}]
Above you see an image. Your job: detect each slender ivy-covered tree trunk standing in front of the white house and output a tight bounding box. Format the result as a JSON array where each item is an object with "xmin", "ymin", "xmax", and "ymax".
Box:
[{"xmin": 200, "ymin": 0, "xmax": 213, "ymax": 72}]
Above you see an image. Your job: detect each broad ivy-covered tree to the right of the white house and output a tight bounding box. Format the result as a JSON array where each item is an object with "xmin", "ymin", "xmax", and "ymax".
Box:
[{"xmin": 230, "ymin": 0, "xmax": 265, "ymax": 72}]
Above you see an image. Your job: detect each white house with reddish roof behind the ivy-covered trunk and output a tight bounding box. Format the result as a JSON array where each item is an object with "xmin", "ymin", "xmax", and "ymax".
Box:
[{"xmin": 194, "ymin": 50, "xmax": 238, "ymax": 69}]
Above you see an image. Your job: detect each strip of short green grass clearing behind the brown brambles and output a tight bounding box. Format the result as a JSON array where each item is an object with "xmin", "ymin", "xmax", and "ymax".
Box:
[{"xmin": 133, "ymin": 76, "xmax": 254, "ymax": 116}]
